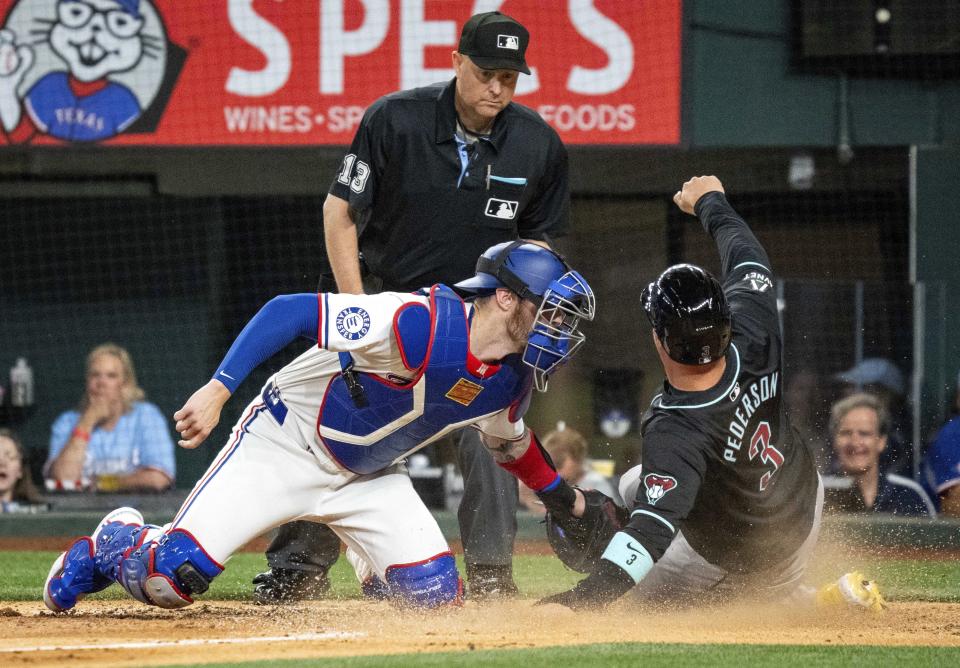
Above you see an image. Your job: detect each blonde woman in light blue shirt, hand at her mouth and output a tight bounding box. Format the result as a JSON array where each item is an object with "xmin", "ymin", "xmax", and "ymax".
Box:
[{"xmin": 44, "ymin": 343, "xmax": 175, "ymax": 492}]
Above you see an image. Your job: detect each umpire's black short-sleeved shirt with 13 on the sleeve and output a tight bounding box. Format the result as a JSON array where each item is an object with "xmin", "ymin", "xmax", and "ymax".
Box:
[{"xmin": 330, "ymin": 79, "xmax": 569, "ymax": 290}]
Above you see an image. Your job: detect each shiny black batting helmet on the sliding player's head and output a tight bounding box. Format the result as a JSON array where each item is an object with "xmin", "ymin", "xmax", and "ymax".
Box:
[{"xmin": 640, "ymin": 264, "xmax": 730, "ymax": 365}]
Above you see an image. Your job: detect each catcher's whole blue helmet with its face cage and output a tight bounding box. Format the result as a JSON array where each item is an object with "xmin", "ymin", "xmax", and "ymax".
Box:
[{"xmin": 453, "ymin": 241, "xmax": 596, "ymax": 392}]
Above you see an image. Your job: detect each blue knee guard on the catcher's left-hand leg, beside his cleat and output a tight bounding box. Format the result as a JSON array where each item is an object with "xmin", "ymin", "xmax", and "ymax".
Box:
[{"xmin": 117, "ymin": 529, "xmax": 223, "ymax": 608}]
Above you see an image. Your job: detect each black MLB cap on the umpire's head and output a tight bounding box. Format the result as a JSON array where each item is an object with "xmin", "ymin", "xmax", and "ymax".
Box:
[{"xmin": 457, "ymin": 12, "xmax": 530, "ymax": 74}]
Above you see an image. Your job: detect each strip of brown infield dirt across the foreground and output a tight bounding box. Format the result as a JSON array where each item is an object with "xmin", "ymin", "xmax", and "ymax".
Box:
[{"xmin": 0, "ymin": 600, "xmax": 960, "ymax": 666}]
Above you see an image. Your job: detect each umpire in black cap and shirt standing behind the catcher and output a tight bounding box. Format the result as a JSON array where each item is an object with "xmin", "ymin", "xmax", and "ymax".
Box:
[{"xmin": 254, "ymin": 12, "xmax": 570, "ymax": 603}]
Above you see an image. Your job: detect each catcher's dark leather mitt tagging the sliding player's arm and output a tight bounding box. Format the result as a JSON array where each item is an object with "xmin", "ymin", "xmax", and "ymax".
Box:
[{"xmin": 546, "ymin": 490, "xmax": 630, "ymax": 573}]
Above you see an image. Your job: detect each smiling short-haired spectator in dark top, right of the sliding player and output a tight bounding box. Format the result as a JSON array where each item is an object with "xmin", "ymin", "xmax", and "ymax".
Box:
[{"xmin": 823, "ymin": 393, "xmax": 936, "ymax": 517}]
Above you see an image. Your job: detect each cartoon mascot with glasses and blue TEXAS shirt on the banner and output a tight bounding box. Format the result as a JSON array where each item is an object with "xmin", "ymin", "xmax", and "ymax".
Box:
[{"xmin": 0, "ymin": 0, "xmax": 185, "ymax": 143}]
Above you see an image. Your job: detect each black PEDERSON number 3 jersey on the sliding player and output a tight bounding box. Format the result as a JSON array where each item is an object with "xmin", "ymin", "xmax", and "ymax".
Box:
[{"xmin": 627, "ymin": 193, "xmax": 818, "ymax": 573}]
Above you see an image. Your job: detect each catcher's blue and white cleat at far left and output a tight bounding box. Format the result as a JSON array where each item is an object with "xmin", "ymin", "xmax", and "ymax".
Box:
[{"xmin": 43, "ymin": 508, "xmax": 143, "ymax": 612}]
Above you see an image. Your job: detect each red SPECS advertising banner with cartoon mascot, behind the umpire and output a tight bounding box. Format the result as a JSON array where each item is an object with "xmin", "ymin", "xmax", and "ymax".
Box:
[{"xmin": 0, "ymin": 0, "xmax": 681, "ymax": 146}]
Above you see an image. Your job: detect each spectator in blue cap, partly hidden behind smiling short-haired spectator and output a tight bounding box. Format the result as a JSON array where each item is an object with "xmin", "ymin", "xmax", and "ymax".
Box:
[{"xmin": 834, "ymin": 357, "xmax": 913, "ymax": 473}]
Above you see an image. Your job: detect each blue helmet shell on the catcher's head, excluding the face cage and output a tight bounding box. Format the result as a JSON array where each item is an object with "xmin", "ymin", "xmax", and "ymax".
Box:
[{"xmin": 453, "ymin": 241, "xmax": 570, "ymax": 306}]
